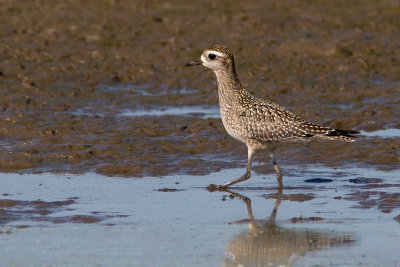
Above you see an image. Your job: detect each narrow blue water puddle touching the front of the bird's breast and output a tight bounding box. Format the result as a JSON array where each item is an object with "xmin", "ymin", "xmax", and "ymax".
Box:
[{"xmin": 120, "ymin": 106, "xmax": 220, "ymax": 118}]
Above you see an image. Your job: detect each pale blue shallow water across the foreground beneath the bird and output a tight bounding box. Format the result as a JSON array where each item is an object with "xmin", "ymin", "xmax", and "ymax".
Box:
[{"xmin": 0, "ymin": 166, "xmax": 400, "ymax": 266}]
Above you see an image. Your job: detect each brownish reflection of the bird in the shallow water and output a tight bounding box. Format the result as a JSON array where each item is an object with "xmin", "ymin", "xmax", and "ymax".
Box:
[{"xmin": 223, "ymin": 190, "xmax": 354, "ymax": 266}]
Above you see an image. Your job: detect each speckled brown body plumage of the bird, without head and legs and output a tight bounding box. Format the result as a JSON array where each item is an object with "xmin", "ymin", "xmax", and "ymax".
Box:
[{"xmin": 219, "ymin": 88, "xmax": 354, "ymax": 145}]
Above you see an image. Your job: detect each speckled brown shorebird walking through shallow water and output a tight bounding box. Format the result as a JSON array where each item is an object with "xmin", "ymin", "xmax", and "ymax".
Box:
[{"xmin": 186, "ymin": 45, "xmax": 359, "ymax": 190}]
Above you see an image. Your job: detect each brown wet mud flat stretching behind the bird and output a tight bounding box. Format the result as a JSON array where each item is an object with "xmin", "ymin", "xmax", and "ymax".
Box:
[{"xmin": 0, "ymin": 0, "xmax": 400, "ymax": 180}]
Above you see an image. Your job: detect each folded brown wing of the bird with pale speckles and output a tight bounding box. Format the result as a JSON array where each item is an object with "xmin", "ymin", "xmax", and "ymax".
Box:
[{"xmin": 241, "ymin": 103, "xmax": 334, "ymax": 142}]
